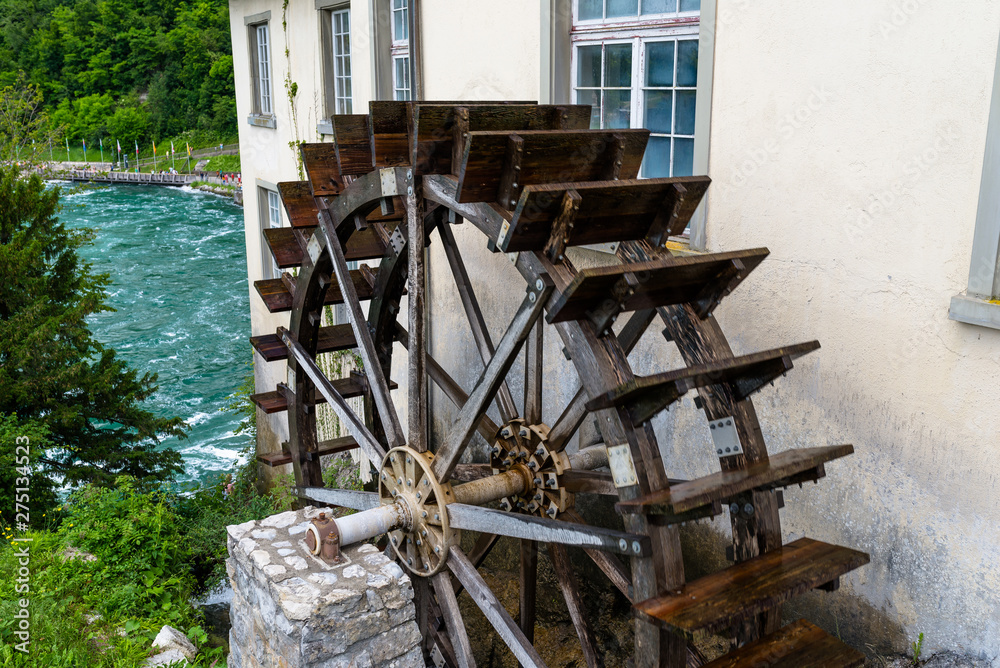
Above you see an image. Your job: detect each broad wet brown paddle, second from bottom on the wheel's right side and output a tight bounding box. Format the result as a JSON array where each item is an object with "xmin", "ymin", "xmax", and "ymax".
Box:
[{"xmin": 635, "ymin": 538, "xmax": 869, "ymax": 633}]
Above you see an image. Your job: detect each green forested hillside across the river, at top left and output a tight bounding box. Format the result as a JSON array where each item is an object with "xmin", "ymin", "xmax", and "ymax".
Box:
[{"xmin": 0, "ymin": 0, "xmax": 236, "ymax": 145}]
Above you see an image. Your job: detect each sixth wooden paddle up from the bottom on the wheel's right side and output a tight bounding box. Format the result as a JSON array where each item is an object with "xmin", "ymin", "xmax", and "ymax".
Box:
[{"xmin": 498, "ymin": 176, "xmax": 710, "ymax": 252}]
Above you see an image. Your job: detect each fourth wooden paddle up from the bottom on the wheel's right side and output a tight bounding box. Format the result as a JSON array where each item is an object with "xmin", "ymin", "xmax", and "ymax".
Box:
[{"xmin": 587, "ymin": 341, "xmax": 819, "ymax": 426}]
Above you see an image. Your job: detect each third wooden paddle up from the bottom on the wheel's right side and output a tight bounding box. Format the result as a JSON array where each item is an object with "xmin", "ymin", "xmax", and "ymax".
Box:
[{"xmin": 615, "ymin": 445, "xmax": 854, "ymax": 514}]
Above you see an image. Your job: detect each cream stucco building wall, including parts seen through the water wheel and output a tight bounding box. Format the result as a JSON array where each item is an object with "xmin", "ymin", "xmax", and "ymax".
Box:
[{"xmin": 231, "ymin": 0, "xmax": 1000, "ymax": 657}]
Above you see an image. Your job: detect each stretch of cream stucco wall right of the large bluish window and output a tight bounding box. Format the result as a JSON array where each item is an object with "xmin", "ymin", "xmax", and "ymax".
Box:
[{"xmin": 688, "ymin": 0, "xmax": 1000, "ymax": 657}]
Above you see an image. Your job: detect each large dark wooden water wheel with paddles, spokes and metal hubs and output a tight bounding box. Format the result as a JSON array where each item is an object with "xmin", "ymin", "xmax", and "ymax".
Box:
[{"xmin": 252, "ymin": 102, "xmax": 868, "ymax": 668}]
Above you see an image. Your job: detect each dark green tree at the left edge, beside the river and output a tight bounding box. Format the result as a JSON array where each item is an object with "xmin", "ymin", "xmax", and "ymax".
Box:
[{"xmin": 0, "ymin": 166, "xmax": 185, "ymax": 500}]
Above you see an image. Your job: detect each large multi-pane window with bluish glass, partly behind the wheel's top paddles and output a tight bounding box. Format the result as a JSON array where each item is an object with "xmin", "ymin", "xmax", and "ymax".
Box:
[{"xmin": 573, "ymin": 0, "xmax": 701, "ymax": 178}]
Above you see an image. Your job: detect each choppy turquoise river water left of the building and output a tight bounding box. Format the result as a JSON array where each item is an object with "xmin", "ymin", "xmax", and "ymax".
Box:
[{"xmin": 61, "ymin": 186, "xmax": 252, "ymax": 483}]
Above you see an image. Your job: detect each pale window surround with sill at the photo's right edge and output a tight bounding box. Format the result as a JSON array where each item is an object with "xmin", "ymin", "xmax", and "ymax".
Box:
[{"xmin": 948, "ymin": 29, "xmax": 1000, "ymax": 329}]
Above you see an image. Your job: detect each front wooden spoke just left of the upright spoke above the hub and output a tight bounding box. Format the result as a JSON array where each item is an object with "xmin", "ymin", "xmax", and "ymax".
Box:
[{"xmin": 319, "ymin": 211, "xmax": 406, "ymax": 447}]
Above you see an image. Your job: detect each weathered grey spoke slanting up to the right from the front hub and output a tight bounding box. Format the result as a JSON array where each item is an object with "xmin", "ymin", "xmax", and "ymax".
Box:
[{"xmin": 433, "ymin": 282, "xmax": 552, "ymax": 480}]
